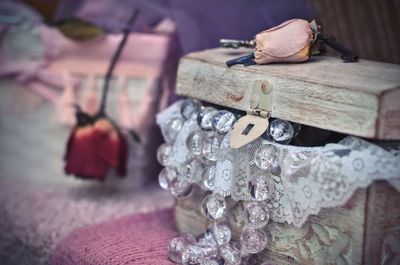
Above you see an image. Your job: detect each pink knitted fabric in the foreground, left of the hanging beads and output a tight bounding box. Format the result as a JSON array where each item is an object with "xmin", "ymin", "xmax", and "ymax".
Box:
[{"xmin": 52, "ymin": 209, "xmax": 176, "ymax": 265}]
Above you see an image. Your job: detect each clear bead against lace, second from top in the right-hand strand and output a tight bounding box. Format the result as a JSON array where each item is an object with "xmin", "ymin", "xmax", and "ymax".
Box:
[{"xmin": 254, "ymin": 144, "xmax": 280, "ymax": 173}]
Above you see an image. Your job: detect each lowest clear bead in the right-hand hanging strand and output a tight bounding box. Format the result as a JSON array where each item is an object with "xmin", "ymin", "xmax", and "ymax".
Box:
[{"xmin": 240, "ymin": 228, "xmax": 268, "ymax": 254}]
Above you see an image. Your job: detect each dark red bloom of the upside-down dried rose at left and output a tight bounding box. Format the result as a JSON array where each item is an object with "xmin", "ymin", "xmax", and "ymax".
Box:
[{"xmin": 64, "ymin": 113, "xmax": 128, "ymax": 181}]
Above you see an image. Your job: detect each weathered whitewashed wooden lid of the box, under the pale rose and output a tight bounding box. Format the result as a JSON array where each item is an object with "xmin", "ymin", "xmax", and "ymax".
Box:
[{"xmin": 176, "ymin": 48, "xmax": 400, "ymax": 140}]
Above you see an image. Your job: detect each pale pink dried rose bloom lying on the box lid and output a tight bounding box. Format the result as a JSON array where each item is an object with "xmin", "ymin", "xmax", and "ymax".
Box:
[{"xmin": 254, "ymin": 19, "xmax": 313, "ymax": 64}]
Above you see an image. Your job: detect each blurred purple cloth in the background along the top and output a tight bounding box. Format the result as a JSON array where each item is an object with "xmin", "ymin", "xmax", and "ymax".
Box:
[{"xmin": 57, "ymin": 0, "xmax": 314, "ymax": 53}]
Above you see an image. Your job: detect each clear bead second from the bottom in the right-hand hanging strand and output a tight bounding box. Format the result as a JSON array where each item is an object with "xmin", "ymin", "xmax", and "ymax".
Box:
[{"xmin": 243, "ymin": 202, "xmax": 269, "ymax": 228}]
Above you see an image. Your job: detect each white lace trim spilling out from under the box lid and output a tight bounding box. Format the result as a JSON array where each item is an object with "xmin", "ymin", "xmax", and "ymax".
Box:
[{"xmin": 157, "ymin": 102, "xmax": 400, "ymax": 227}]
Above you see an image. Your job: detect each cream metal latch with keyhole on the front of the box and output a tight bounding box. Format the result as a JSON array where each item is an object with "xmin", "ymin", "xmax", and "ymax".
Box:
[{"xmin": 230, "ymin": 80, "xmax": 273, "ymax": 148}]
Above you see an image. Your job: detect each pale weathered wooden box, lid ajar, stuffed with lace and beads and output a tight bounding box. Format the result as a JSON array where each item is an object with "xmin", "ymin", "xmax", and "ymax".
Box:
[{"xmin": 176, "ymin": 49, "xmax": 400, "ymax": 265}]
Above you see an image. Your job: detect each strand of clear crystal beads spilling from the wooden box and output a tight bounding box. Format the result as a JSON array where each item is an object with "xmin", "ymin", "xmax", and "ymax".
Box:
[{"xmin": 157, "ymin": 99, "xmax": 298, "ymax": 265}]
